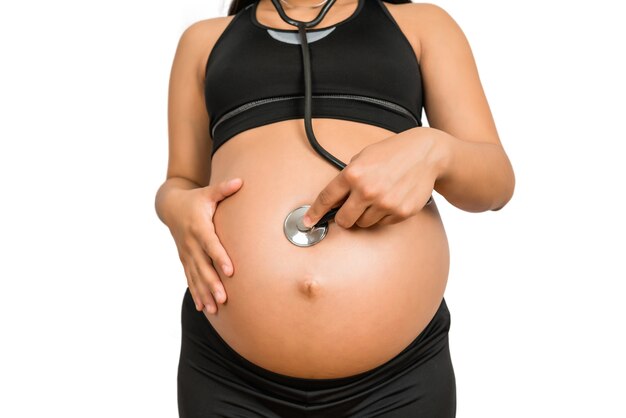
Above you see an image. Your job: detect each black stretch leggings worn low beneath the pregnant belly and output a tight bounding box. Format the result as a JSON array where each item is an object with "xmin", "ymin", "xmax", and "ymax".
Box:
[{"xmin": 178, "ymin": 288, "xmax": 456, "ymax": 418}]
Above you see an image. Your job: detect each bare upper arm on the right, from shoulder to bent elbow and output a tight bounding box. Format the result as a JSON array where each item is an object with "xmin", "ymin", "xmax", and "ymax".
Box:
[{"xmin": 414, "ymin": 3, "xmax": 502, "ymax": 146}]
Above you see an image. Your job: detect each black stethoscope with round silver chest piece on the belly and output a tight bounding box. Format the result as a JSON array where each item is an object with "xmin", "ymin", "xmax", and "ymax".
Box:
[{"xmin": 272, "ymin": 0, "xmax": 433, "ymax": 247}]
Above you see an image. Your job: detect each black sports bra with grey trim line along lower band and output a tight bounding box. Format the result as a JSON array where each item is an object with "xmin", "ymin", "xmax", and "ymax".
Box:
[{"xmin": 204, "ymin": 0, "xmax": 423, "ymax": 157}]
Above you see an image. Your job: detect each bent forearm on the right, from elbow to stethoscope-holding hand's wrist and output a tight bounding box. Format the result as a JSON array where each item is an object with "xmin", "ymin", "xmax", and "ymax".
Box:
[{"xmin": 420, "ymin": 128, "xmax": 515, "ymax": 212}]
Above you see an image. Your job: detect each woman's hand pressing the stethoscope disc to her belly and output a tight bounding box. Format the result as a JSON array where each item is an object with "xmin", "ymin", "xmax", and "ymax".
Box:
[{"xmin": 302, "ymin": 127, "xmax": 445, "ymax": 228}]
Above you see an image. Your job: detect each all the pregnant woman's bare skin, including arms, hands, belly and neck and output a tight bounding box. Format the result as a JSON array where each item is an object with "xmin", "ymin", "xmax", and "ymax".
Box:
[{"xmin": 155, "ymin": 0, "xmax": 515, "ymax": 378}]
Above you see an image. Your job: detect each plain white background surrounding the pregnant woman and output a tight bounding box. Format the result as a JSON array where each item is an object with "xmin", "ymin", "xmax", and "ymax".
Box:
[{"xmin": 0, "ymin": 0, "xmax": 626, "ymax": 418}]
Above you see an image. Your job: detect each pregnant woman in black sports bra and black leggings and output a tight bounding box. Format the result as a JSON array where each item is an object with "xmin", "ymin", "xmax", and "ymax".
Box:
[{"xmin": 155, "ymin": 0, "xmax": 515, "ymax": 418}]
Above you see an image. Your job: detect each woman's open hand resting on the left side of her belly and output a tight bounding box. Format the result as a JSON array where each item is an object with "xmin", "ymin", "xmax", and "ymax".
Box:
[{"xmin": 169, "ymin": 178, "xmax": 243, "ymax": 314}]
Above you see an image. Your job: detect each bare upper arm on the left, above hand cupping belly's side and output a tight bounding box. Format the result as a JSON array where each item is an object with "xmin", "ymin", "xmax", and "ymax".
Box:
[{"xmin": 167, "ymin": 16, "xmax": 232, "ymax": 186}]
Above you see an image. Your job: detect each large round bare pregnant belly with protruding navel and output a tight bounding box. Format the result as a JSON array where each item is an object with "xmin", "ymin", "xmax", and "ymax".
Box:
[{"xmin": 206, "ymin": 119, "xmax": 449, "ymax": 378}]
